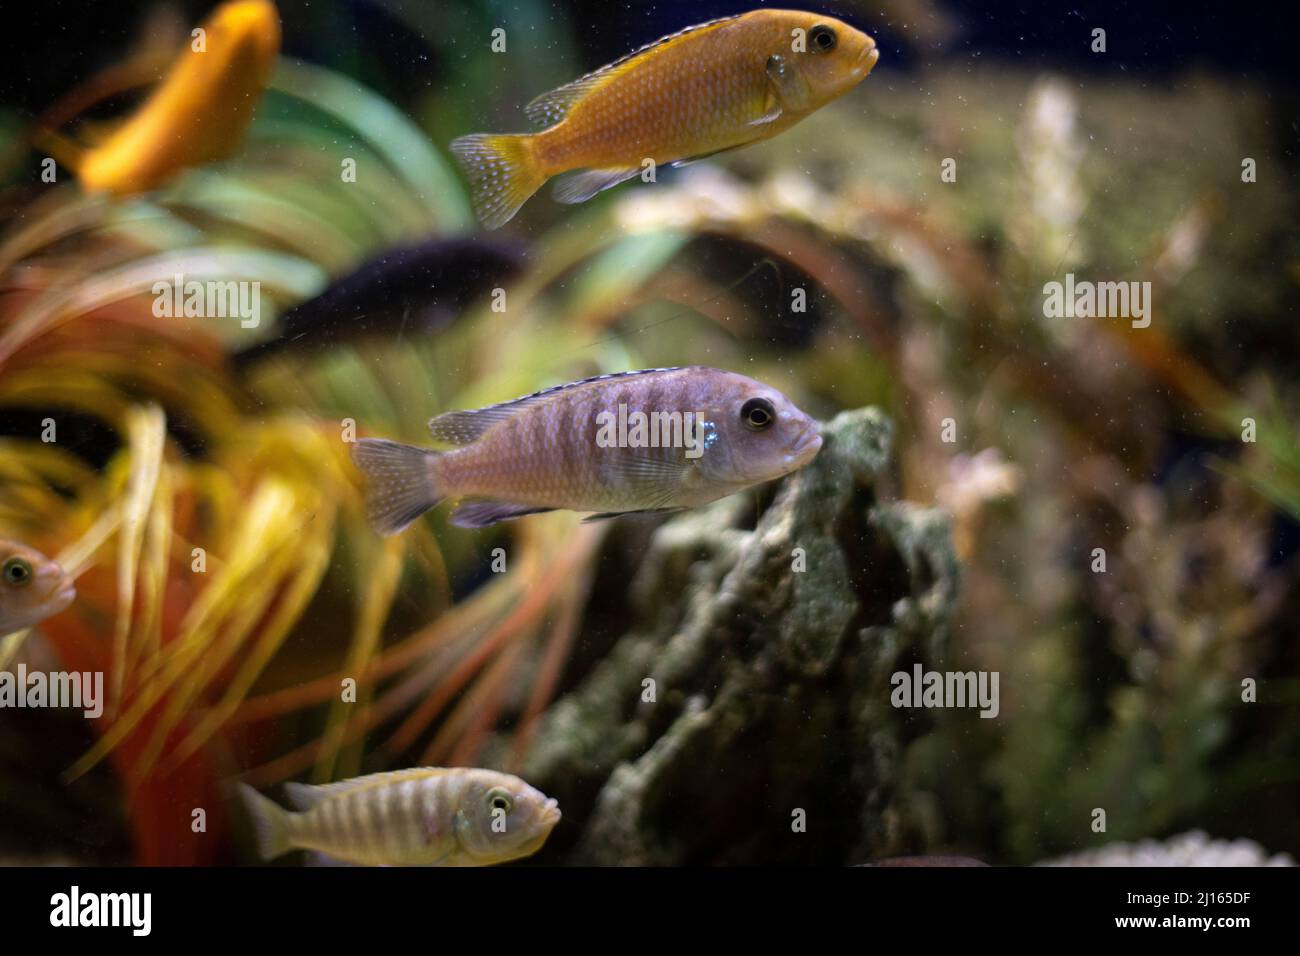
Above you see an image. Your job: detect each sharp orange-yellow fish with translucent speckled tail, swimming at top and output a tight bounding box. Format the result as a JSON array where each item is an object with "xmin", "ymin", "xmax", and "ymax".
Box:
[{"xmin": 451, "ymin": 9, "xmax": 879, "ymax": 229}]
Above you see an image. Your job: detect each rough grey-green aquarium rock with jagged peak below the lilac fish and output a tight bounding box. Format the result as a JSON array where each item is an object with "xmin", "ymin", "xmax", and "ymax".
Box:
[{"xmin": 523, "ymin": 408, "xmax": 957, "ymax": 865}]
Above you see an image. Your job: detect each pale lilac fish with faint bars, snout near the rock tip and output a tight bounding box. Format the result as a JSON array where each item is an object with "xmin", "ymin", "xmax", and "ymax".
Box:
[{"xmin": 352, "ymin": 365, "xmax": 822, "ymax": 535}]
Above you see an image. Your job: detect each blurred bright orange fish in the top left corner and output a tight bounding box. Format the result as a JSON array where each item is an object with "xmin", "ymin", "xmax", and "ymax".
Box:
[{"xmin": 45, "ymin": 0, "xmax": 280, "ymax": 196}]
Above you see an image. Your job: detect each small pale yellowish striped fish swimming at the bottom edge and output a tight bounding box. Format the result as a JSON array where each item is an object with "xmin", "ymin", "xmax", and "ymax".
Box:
[{"xmin": 239, "ymin": 767, "xmax": 560, "ymax": 866}]
